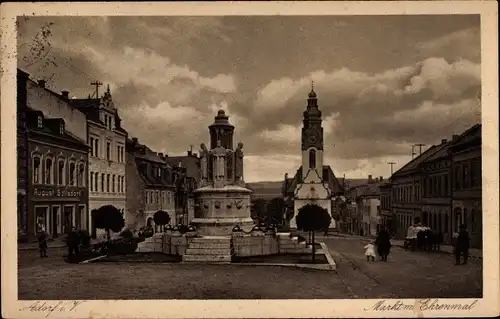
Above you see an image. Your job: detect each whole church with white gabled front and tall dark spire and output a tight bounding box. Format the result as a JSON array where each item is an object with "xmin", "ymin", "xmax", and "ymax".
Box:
[{"xmin": 283, "ymin": 89, "xmax": 344, "ymax": 229}]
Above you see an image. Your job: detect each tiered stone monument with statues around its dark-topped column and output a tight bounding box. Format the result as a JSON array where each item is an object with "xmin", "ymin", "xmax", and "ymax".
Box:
[{"xmin": 191, "ymin": 110, "xmax": 254, "ymax": 236}]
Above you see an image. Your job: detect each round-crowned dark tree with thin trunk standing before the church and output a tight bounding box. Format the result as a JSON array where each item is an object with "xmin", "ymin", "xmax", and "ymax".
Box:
[{"xmin": 296, "ymin": 204, "xmax": 332, "ymax": 260}]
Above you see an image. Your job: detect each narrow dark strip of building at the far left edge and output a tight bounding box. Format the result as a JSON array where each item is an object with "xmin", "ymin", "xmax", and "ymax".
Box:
[{"xmin": 17, "ymin": 69, "xmax": 29, "ymax": 240}]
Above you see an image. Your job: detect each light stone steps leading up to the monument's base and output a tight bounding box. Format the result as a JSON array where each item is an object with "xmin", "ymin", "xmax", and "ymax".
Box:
[{"xmin": 182, "ymin": 236, "xmax": 233, "ymax": 264}]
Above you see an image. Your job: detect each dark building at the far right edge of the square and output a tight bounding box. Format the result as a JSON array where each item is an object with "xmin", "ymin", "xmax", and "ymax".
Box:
[{"xmin": 450, "ymin": 124, "xmax": 482, "ymax": 248}]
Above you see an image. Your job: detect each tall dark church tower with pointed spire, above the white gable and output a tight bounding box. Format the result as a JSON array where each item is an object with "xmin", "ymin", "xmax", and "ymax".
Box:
[{"xmin": 302, "ymin": 87, "xmax": 323, "ymax": 183}]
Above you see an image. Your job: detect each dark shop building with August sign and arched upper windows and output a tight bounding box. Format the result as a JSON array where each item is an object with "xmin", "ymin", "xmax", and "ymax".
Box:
[{"xmin": 26, "ymin": 109, "xmax": 89, "ymax": 238}]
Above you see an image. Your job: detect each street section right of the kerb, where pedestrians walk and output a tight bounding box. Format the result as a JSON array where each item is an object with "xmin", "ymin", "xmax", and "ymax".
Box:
[{"xmin": 318, "ymin": 237, "xmax": 483, "ymax": 298}]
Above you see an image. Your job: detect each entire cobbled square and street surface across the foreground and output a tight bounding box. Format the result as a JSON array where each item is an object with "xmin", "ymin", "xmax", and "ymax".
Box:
[{"xmin": 18, "ymin": 237, "xmax": 482, "ymax": 299}]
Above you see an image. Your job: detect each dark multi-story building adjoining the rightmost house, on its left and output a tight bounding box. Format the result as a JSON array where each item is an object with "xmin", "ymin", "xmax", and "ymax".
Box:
[{"xmin": 420, "ymin": 139, "xmax": 452, "ymax": 244}]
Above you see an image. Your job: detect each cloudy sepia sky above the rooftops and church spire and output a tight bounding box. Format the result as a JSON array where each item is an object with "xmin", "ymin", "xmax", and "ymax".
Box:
[{"xmin": 18, "ymin": 15, "xmax": 481, "ymax": 182}]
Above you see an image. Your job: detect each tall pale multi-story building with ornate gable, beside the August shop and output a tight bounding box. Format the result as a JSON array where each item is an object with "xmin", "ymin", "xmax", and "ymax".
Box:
[{"xmin": 70, "ymin": 86, "xmax": 127, "ymax": 238}]
